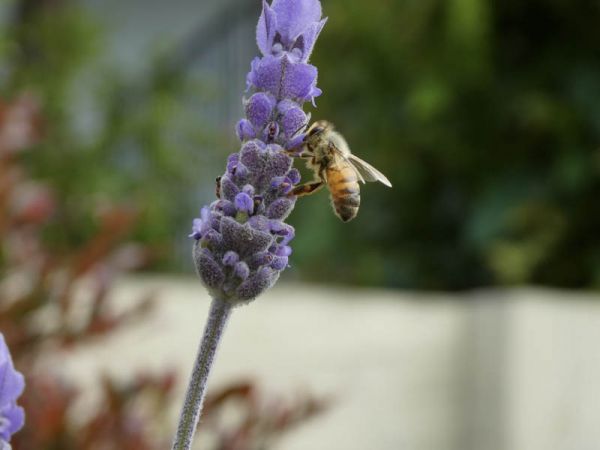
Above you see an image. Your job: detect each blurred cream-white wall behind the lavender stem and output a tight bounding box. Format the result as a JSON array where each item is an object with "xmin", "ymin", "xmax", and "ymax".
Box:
[{"xmin": 54, "ymin": 279, "xmax": 600, "ymax": 450}]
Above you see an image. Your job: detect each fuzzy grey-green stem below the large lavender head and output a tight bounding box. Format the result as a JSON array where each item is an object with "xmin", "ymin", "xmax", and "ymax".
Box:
[{"xmin": 171, "ymin": 298, "xmax": 231, "ymax": 450}]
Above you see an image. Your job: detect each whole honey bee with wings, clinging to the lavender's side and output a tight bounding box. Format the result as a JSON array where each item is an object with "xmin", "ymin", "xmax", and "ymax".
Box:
[{"xmin": 291, "ymin": 120, "xmax": 392, "ymax": 222}]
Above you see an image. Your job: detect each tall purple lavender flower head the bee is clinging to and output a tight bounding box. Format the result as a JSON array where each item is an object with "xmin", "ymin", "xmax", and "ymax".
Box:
[{"xmin": 190, "ymin": 0, "xmax": 326, "ymax": 304}]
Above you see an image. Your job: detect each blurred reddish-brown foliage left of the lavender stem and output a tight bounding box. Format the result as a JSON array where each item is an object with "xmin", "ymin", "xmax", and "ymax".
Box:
[{"xmin": 0, "ymin": 95, "xmax": 173, "ymax": 450}]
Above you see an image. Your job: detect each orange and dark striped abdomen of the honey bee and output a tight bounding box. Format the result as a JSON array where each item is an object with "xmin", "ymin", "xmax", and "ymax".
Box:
[{"xmin": 327, "ymin": 164, "xmax": 360, "ymax": 222}]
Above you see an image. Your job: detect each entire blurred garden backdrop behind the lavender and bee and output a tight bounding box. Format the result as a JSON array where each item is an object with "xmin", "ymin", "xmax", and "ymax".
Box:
[{"xmin": 0, "ymin": 0, "xmax": 600, "ymax": 450}]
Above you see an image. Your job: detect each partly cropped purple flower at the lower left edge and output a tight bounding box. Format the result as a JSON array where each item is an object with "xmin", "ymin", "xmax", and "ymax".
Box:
[{"xmin": 0, "ymin": 333, "xmax": 25, "ymax": 450}]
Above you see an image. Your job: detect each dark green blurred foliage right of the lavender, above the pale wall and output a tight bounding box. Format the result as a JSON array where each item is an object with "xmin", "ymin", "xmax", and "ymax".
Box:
[{"xmin": 293, "ymin": 0, "xmax": 600, "ymax": 289}]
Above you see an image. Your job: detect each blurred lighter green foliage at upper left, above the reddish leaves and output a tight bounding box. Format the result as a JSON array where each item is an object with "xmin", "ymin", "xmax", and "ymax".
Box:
[{"xmin": 0, "ymin": 0, "xmax": 215, "ymax": 269}]
